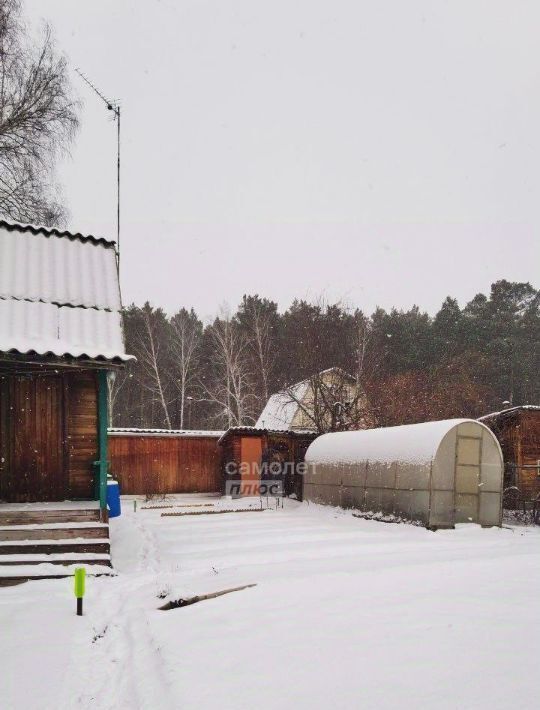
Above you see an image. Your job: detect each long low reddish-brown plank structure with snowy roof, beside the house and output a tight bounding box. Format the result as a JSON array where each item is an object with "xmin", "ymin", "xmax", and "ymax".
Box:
[{"xmin": 109, "ymin": 429, "xmax": 223, "ymax": 495}]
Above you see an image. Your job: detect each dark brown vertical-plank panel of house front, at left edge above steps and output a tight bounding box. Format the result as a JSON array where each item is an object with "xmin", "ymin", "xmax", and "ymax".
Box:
[{"xmin": 0, "ymin": 374, "xmax": 67, "ymax": 503}]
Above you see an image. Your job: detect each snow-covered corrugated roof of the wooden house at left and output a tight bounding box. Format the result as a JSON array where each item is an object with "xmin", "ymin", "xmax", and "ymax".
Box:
[{"xmin": 0, "ymin": 220, "xmax": 130, "ymax": 360}]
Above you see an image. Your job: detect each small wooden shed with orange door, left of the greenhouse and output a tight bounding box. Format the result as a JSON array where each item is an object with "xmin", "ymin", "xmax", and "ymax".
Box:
[{"xmin": 219, "ymin": 427, "xmax": 318, "ymax": 500}]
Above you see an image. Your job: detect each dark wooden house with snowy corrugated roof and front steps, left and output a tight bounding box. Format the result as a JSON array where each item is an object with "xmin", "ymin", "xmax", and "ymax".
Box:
[{"xmin": 0, "ymin": 221, "xmax": 129, "ymax": 578}]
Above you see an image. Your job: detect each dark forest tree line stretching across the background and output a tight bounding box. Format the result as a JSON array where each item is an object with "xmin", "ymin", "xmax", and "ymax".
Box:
[{"xmin": 110, "ymin": 280, "xmax": 540, "ymax": 429}]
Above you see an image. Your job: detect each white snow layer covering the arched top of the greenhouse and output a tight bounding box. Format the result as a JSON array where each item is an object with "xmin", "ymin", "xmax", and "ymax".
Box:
[{"xmin": 306, "ymin": 419, "xmax": 484, "ymax": 464}]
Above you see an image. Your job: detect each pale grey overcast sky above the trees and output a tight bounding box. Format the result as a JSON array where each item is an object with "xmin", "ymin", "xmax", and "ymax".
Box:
[{"xmin": 25, "ymin": 0, "xmax": 540, "ymax": 317}]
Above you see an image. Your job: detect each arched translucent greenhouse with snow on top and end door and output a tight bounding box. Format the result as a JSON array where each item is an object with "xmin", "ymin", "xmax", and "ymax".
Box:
[{"xmin": 304, "ymin": 419, "xmax": 503, "ymax": 528}]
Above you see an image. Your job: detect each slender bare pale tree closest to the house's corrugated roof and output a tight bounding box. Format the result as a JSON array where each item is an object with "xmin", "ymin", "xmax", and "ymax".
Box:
[{"xmin": 132, "ymin": 303, "xmax": 172, "ymax": 429}]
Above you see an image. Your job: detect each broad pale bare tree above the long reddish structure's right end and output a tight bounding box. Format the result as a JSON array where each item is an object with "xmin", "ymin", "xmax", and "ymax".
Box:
[{"xmin": 200, "ymin": 314, "xmax": 257, "ymax": 427}]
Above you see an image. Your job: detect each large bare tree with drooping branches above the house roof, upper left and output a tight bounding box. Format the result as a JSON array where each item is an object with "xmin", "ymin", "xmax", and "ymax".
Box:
[{"xmin": 0, "ymin": 0, "xmax": 78, "ymax": 225}]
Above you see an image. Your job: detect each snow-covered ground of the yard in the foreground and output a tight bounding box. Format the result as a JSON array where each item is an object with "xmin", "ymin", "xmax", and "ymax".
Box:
[{"xmin": 0, "ymin": 496, "xmax": 540, "ymax": 710}]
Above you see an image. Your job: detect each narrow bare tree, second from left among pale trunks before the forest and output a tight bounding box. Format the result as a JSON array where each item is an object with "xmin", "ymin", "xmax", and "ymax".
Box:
[{"xmin": 171, "ymin": 308, "xmax": 202, "ymax": 429}]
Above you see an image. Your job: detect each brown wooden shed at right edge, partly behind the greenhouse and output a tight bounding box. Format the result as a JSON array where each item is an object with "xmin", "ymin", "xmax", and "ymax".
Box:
[{"xmin": 479, "ymin": 405, "xmax": 540, "ymax": 501}]
